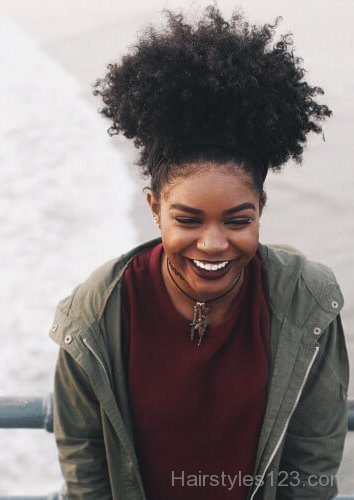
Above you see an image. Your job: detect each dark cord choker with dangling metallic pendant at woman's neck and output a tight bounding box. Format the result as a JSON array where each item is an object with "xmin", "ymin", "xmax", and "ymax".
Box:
[{"xmin": 167, "ymin": 257, "xmax": 243, "ymax": 346}]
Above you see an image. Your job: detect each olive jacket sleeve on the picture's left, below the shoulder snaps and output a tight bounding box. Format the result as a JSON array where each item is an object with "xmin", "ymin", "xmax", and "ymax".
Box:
[{"xmin": 54, "ymin": 349, "xmax": 112, "ymax": 500}]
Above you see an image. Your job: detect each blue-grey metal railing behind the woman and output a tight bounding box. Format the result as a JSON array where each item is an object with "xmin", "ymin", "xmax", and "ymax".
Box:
[{"xmin": 0, "ymin": 394, "xmax": 354, "ymax": 500}]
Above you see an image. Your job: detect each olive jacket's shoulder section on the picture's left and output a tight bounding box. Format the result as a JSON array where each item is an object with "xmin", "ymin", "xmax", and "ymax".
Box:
[{"xmin": 51, "ymin": 239, "xmax": 161, "ymax": 329}]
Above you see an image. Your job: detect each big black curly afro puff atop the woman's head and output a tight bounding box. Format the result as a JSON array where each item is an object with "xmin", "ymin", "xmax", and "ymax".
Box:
[{"xmin": 94, "ymin": 6, "xmax": 331, "ymax": 192}]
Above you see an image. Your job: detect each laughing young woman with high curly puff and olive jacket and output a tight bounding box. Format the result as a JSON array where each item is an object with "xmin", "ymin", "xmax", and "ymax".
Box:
[{"xmin": 51, "ymin": 7, "xmax": 348, "ymax": 500}]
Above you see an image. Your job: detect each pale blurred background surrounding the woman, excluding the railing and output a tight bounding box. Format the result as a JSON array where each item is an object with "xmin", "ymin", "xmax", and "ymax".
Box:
[{"xmin": 0, "ymin": 0, "xmax": 354, "ymax": 495}]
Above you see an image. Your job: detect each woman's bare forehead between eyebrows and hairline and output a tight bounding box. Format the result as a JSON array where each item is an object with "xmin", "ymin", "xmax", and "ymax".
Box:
[{"xmin": 162, "ymin": 164, "xmax": 257, "ymax": 204}]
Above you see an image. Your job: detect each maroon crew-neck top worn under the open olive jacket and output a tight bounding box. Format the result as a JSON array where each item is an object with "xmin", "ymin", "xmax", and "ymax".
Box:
[{"xmin": 123, "ymin": 244, "xmax": 269, "ymax": 500}]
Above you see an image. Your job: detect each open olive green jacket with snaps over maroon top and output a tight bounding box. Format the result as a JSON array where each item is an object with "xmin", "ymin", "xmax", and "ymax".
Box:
[{"xmin": 50, "ymin": 240, "xmax": 349, "ymax": 500}]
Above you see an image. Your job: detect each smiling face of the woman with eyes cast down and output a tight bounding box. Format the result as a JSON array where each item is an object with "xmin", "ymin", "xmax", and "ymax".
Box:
[{"xmin": 147, "ymin": 164, "xmax": 261, "ymax": 301}]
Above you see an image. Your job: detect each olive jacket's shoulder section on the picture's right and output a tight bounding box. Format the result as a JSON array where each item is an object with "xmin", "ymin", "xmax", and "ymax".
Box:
[{"xmin": 258, "ymin": 245, "xmax": 344, "ymax": 322}]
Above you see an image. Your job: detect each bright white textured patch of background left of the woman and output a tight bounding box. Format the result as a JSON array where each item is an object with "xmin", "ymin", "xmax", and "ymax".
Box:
[{"xmin": 0, "ymin": 19, "xmax": 136, "ymax": 494}]
